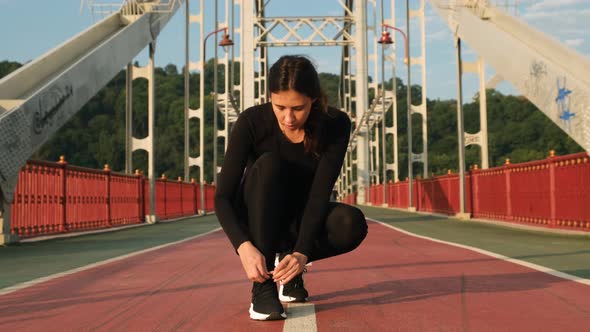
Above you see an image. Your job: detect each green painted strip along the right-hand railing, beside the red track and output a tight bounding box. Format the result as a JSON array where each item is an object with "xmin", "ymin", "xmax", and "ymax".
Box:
[{"xmin": 359, "ymin": 206, "xmax": 590, "ymax": 278}]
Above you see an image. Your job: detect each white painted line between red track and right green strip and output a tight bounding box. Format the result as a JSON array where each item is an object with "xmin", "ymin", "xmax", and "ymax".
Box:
[{"xmin": 366, "ymin": 218, "xmax": 590, "ymax": 286}]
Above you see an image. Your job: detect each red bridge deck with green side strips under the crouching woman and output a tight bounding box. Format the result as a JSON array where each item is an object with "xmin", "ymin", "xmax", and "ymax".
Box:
[{"xmin": 0, "ymin": 208, "xmax": 590, "ymax": 331}]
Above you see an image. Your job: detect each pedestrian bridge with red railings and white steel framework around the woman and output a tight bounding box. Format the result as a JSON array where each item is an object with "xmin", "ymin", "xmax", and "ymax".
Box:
[{"xmin": 0, "ymin": 0, "xmax": 590, "ymax": 331}]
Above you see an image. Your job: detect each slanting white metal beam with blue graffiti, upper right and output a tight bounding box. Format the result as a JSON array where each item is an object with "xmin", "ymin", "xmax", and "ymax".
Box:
[{"xmin": 430, "ymin": 0, "xmax": 590, "ymax": 151}]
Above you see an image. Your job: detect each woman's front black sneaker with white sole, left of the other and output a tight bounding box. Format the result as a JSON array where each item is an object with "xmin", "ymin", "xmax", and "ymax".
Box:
[{"xmin": 249, "ymin": 279, "xmax": 287, "ymax": 320}]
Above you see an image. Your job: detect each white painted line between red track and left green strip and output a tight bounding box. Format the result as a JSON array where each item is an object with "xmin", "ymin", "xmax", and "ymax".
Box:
[{"xmin": 0, "ymin": 227, "xmax": 221, "ymax": 295}]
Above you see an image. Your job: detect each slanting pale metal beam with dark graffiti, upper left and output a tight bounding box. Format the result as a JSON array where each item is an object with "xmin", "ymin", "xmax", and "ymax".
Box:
[{"xmin": 0, "ymin": 5, "xmax": 182, "ymax": 201}]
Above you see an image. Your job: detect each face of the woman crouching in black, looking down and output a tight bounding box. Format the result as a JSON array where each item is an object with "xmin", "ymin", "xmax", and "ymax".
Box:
[{"xmin": 270, "ymin": 90, "xmax": 315, "ymax": 131}]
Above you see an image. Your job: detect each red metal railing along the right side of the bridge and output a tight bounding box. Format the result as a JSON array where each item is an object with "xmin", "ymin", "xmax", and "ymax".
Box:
[{"xmin": 352, "ymin": 153, "xmax": 590, "ymax": 231}]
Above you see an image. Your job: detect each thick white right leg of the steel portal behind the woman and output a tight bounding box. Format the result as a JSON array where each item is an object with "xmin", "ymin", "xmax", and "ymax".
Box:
[{"xmin": 354, "ymin": 0, "xmax": 369, "ymax": 204}]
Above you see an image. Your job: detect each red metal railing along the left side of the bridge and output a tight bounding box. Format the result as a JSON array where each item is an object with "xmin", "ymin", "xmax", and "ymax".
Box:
[{"xmin": 11, "ymin": 159, "xmax": 215, "ymax": 237}]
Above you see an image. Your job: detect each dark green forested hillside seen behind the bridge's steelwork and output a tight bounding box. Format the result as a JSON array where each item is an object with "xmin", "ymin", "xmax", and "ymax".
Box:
[{"xmin": 0, "ymin": 61, "xmax": 583, "ymax": 182}]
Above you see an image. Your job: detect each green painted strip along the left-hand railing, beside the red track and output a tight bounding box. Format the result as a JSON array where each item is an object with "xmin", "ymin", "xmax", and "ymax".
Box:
[{"xmin": 0, "ymin": 215, "xmax": 219, "ymax": 289}]
